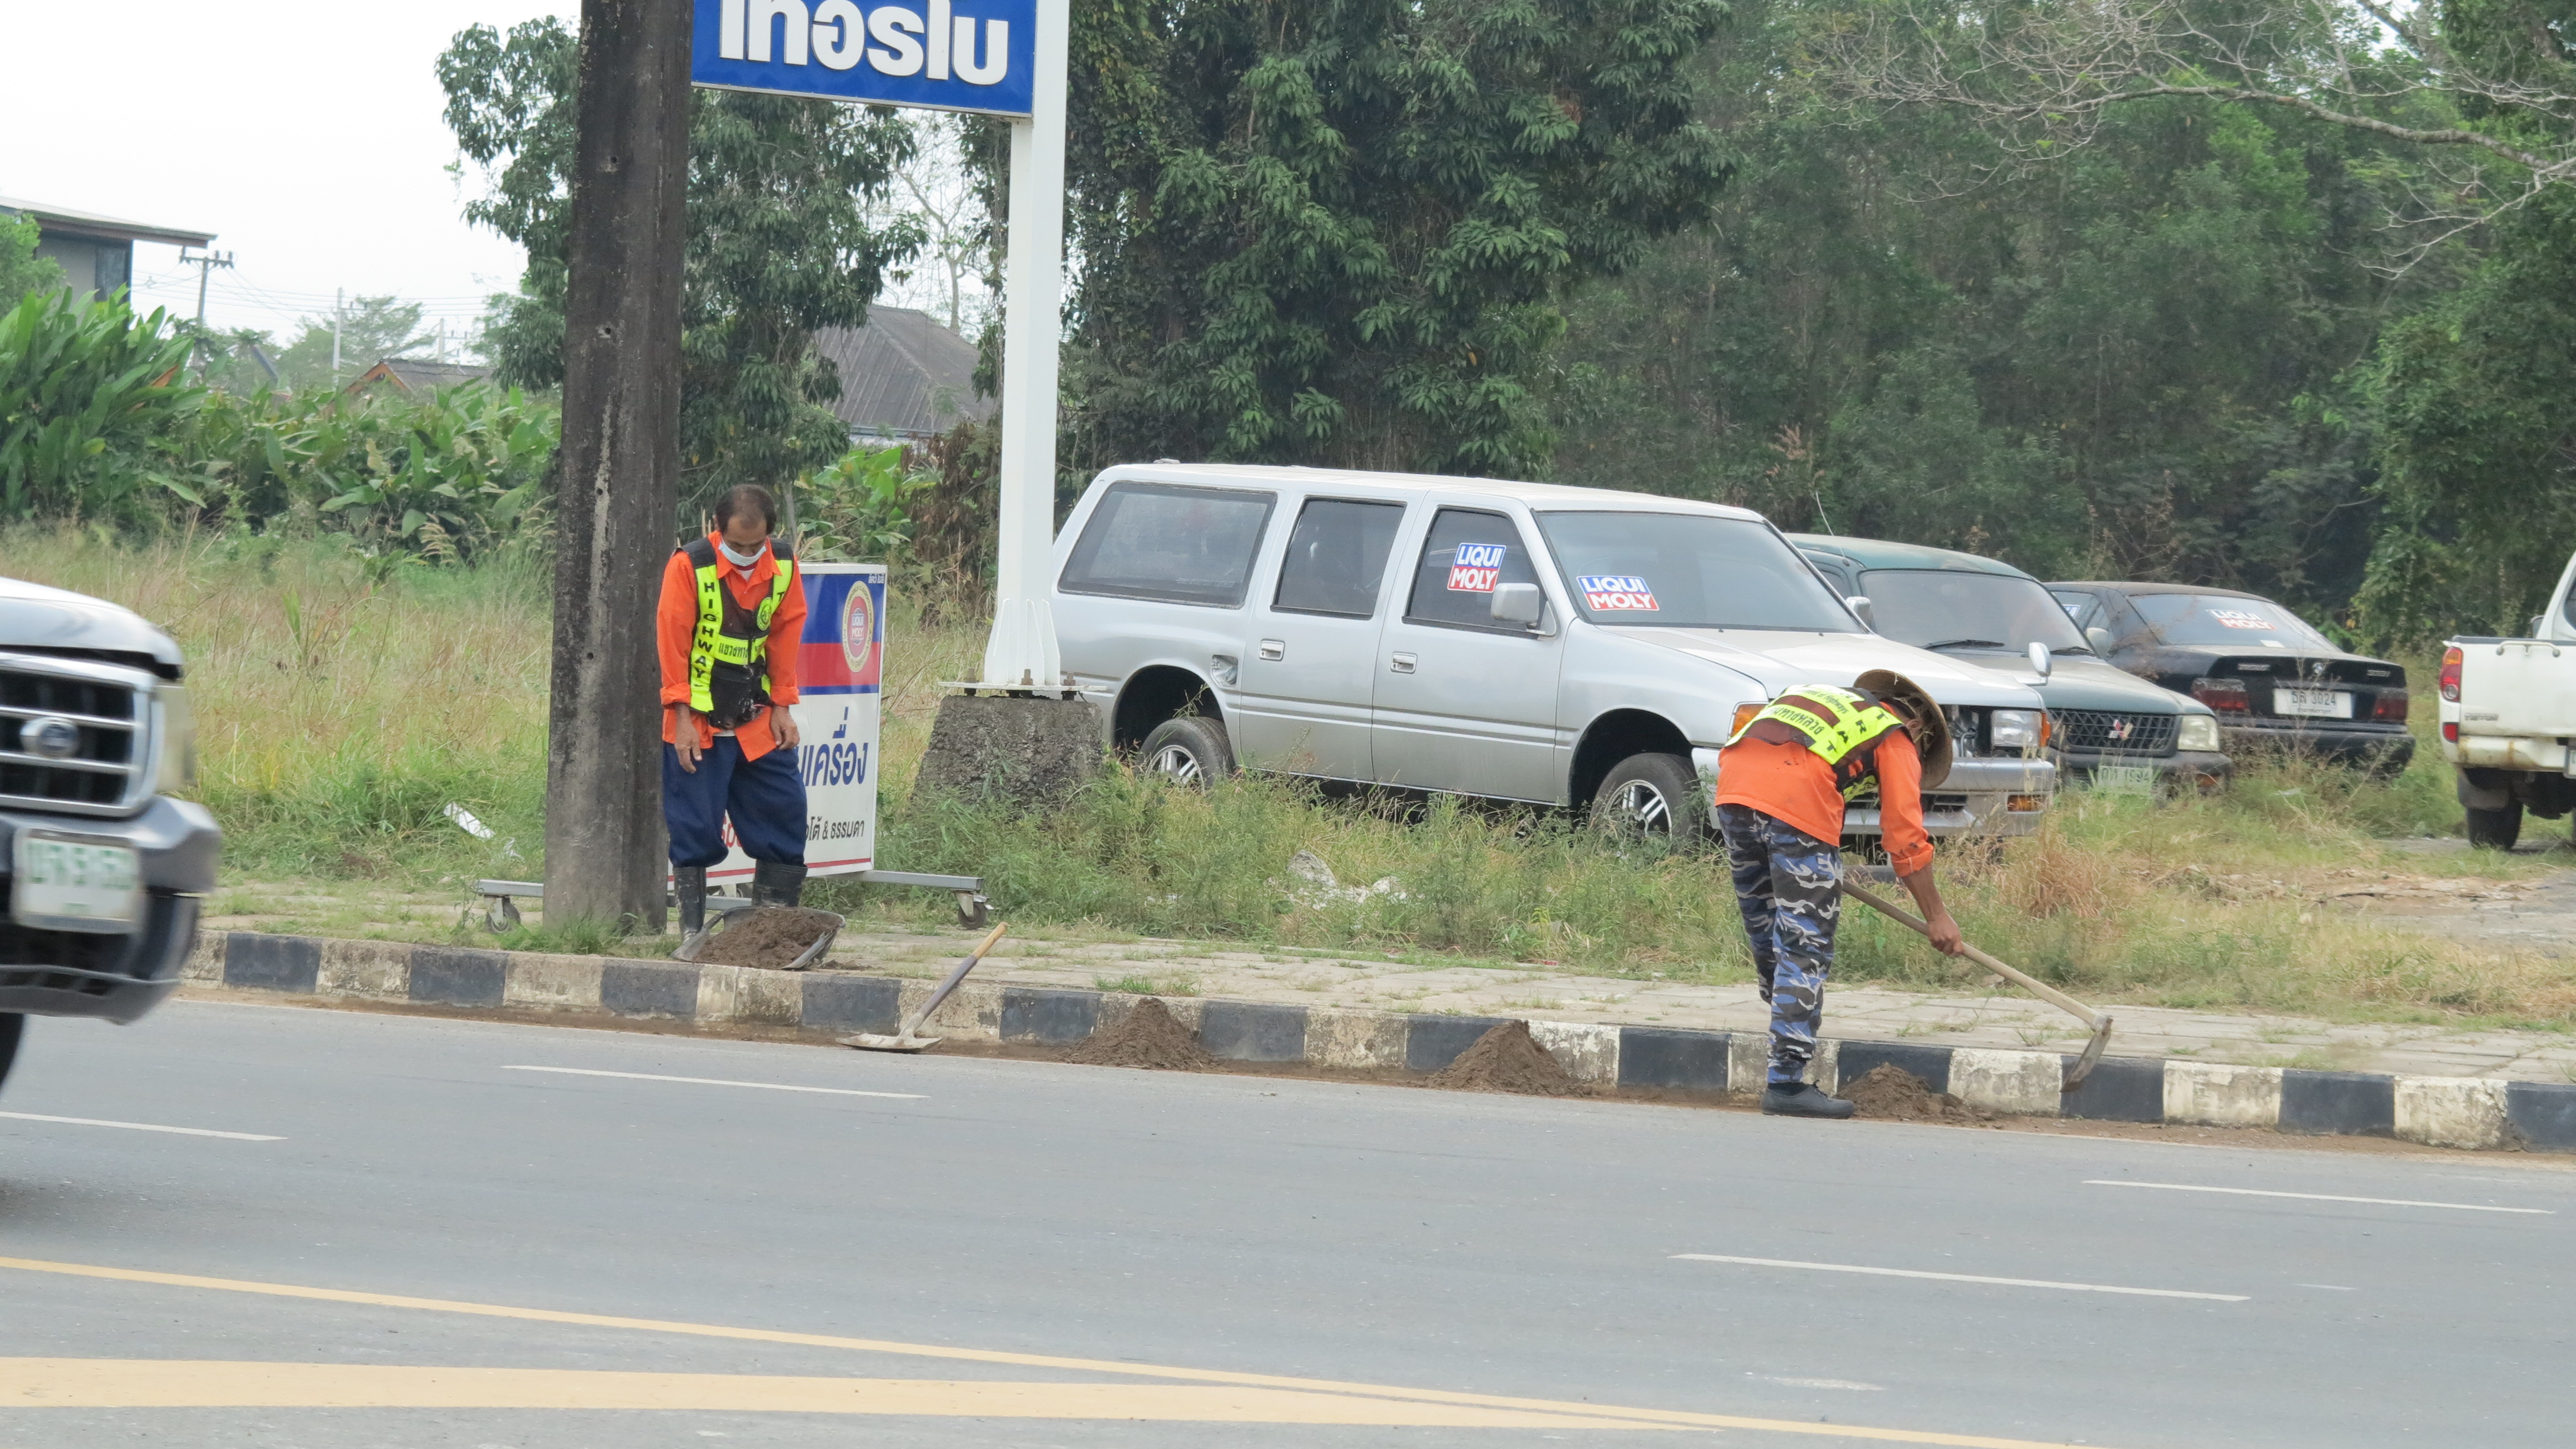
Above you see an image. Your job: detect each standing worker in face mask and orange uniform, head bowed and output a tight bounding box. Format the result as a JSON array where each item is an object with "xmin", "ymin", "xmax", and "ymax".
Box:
[{"xmin": 657, "ymin": 485, "xmax": 806, "ymax": 936}]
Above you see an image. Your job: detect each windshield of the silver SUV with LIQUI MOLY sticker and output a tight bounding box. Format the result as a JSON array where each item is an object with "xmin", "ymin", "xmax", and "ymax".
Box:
[{"xmin": 1538, "ymin": 513, "xmax": 1860, "ymax": 635}]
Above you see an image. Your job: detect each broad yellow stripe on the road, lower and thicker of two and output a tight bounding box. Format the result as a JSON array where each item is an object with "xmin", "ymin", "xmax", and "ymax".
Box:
[{"xmin": 0, "ymin": 1359, "xmax": 1661, "ymax": 1428}]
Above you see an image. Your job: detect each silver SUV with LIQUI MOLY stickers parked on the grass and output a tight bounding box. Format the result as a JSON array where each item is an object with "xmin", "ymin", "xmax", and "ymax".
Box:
[{"xmin": 1054, "ymin": 464, "xmax": 2056, "ymax": 841}]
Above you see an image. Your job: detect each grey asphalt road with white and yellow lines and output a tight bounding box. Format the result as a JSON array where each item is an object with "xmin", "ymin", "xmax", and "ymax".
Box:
[{"xmin": 0, "ymin": 1003, "xmax": 2576, "ymax": 1449}]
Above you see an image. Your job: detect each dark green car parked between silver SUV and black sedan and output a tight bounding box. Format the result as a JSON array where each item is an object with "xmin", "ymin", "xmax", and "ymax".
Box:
[{"xmin": 1791, "ymin": 534, "xmax": 2231, "ymax": 787}]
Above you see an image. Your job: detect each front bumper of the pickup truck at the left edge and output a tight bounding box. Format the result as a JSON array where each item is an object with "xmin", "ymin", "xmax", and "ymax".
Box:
[{"xmin": 0, "ymin": 797, "xmax": 224, "ymax": 1021}]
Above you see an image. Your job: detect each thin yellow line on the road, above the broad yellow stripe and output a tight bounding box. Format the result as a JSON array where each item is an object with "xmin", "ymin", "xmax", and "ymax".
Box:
[{"xmin": 0, "ymin": 1258, "xmax": 2102, "ymax": 1449}]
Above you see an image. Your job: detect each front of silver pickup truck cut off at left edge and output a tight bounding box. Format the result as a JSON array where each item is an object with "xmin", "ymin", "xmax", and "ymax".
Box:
[{"xmin": 0, "ymin": 578, "xmax": 224, "ymax": 1078}]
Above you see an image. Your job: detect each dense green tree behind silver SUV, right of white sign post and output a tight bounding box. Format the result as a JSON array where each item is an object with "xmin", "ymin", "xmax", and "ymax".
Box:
[{"xmin": 1056, "ymin": 0, "xmax": 1728, "ymax": 474}]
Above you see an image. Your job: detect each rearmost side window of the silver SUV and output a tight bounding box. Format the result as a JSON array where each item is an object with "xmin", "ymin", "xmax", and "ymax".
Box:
[{"xmin": 1056, "ymin": 482, "xmax": 1278, "ymax": 608}]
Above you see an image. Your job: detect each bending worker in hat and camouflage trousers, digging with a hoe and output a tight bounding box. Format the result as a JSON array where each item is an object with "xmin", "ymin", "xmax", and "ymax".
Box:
[{"xmin": 1718, "ymin": 671, "xmax": 1963, "ymax": 1116}]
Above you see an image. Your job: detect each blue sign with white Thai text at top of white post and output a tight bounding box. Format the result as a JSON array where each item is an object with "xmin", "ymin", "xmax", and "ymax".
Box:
[{"xmin": 688, "ymin": 0, "xmax": 1038, "ymax": 116}]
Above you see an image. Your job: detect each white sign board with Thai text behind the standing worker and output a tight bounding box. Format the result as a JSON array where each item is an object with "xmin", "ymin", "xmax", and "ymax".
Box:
[{"xmin": 706, "ymin": 559, "xmax": 886, "ymax": 884}]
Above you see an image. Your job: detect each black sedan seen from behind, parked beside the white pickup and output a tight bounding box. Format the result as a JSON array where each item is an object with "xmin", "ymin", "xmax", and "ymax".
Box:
[{"xmin": 2048, "ymin": 582, "xmax": 2414, "ymax": 774}]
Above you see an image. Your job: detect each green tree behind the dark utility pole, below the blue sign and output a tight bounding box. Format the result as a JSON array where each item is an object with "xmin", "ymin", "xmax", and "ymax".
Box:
[{"xmin": 438, "ymin": 18, "xmax": 922, "ymax": 516}]
